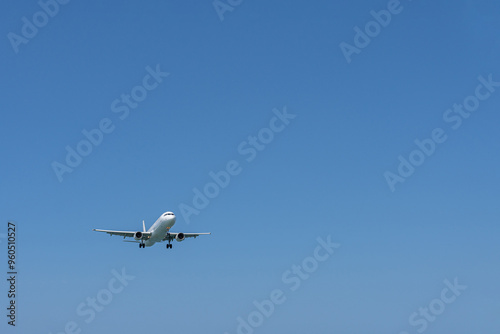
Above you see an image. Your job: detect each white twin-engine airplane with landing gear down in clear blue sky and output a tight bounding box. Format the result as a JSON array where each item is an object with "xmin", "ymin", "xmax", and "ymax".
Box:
[{"xmin": 93, "ymin": 211, "xmax": 210, "ymax": 249}]
